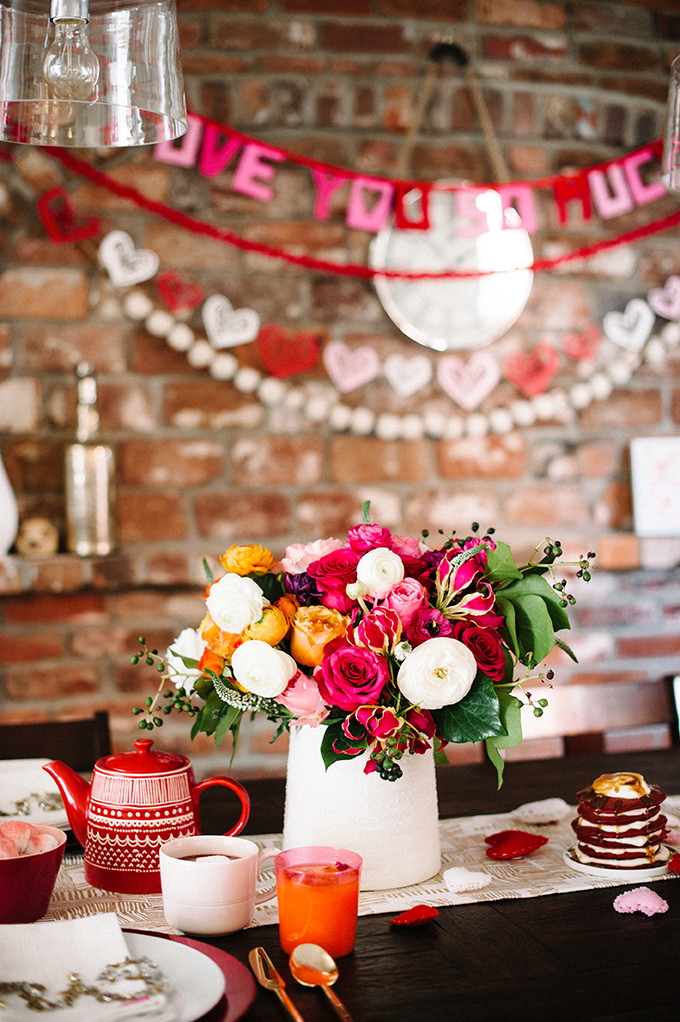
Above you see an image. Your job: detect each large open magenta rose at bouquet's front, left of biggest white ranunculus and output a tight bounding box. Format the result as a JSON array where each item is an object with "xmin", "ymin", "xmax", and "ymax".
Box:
[{"xmin": 314, "ymin": 639, "xmax": 390, "ymax": 710}]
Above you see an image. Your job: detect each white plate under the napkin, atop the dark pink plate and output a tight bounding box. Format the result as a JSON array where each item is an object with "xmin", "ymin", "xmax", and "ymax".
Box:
[{"xmin": 125, "ymin": 933, "xmax": 225, "ymax": 1022}]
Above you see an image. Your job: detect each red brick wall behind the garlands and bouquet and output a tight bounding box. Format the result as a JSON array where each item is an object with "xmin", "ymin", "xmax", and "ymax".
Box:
[{"xmin": 0, "ymin": 0, "xmax": 680, "ymax": 776}]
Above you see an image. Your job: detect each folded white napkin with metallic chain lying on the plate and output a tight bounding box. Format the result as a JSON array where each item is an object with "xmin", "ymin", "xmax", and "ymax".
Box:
[{"xmin": 0, "ymin": 913, "xmax": 175, "ymax": 1022}]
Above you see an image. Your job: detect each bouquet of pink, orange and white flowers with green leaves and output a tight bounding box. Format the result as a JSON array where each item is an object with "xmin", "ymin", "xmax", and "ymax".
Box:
[{"xmin": 133, "ymin": 504, "xmax": 594, "ymax": 784}]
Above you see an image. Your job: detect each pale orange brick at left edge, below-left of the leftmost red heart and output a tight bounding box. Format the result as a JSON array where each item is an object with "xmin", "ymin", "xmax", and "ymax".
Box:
[{"xmin": 0, "ymin": 267, "xmax": 88, "ymax": 320}]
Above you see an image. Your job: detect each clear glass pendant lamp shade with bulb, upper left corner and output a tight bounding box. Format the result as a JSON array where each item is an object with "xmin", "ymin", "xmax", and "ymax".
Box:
[{"xmin": 0, "ymin": 0, "xmax": 187, "ymax": 148}]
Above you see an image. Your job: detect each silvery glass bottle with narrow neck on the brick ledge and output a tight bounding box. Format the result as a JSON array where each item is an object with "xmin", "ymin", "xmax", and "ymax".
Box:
[{"xmin": 65, "ymin": 362, "xmax": 115, "ymax": 557}]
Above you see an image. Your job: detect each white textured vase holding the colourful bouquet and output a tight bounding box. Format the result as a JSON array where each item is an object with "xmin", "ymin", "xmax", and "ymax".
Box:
[{"xmin": 283, "ymin": 727, "xmax": 442, "ymax": 890}]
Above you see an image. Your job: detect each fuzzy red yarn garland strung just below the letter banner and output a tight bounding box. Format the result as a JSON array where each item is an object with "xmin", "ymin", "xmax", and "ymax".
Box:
[{"xmin": 50, "ymin": 149, "xmax": 680, "ymax": 280}]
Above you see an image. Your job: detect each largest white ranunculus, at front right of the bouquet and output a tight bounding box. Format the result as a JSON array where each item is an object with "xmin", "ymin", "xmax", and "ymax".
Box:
[{"xmin": 397, "ymin": 636, "xmax": 477, "ymax": 709}]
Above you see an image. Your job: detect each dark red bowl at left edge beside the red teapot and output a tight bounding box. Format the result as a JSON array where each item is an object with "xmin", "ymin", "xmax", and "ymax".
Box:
[{"xmin": 0, "ymin": 821, "xmax": 66, "ymax": 923}]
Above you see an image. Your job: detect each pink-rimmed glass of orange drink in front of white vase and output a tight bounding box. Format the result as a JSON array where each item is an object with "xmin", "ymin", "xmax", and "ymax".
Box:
[{"xmin": 274, "ymin": 845, "xmax": 361, "ymax": 958}]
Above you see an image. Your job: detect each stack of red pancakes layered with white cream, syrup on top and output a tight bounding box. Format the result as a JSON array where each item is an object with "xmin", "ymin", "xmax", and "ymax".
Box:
[{"xmin": 572, "ymin": 774, "xmax": 671, "ymax": 870}]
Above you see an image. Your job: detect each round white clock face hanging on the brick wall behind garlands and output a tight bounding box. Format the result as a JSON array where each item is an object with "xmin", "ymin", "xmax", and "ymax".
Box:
[{"xmin": 370, "ymin": 189, "xmax": 534, "ymax": 352}]
